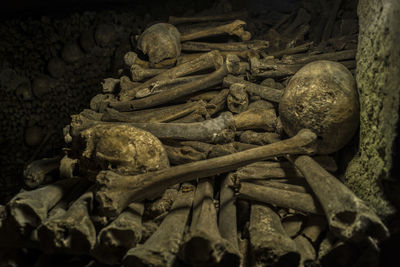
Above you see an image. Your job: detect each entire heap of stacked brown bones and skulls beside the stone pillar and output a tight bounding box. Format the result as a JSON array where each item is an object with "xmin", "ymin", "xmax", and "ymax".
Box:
[{"xmin": 0, "ymin": 6, "xmax": 388, "ymax": 266}]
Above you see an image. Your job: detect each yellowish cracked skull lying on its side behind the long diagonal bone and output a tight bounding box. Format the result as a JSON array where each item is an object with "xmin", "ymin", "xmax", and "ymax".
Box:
[{"xmin": 74, "ymin": 124, "xmax": 169, "ymax": 178}]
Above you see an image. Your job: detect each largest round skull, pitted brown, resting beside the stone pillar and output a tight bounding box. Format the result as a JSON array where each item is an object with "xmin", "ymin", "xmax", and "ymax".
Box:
[{"xmin": 279, "ymin": 60, "xmax": 359, "ymax": 154}]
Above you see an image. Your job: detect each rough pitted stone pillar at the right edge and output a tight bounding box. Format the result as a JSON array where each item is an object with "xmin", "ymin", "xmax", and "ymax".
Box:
[{"xmin": 346, "ymin": 0, "xmax": 400, "ymax": 216}]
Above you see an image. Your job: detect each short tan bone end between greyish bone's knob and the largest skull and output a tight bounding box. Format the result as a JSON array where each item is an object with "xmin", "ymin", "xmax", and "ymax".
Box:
[{"xmin": 234, "ymin": 108, "xmax": 277, "ymax": 131}]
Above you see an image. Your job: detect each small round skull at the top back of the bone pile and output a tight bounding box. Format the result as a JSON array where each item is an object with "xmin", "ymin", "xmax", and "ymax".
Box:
[{"xmin": 137, "ymin": 23, "xmax": 181, "ymax": 64}]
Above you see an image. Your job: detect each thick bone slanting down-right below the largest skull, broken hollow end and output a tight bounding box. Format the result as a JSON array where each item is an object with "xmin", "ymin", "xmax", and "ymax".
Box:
[{"xmin": 293, "ymin": 156, "xmax": 389, "ymax": 245}]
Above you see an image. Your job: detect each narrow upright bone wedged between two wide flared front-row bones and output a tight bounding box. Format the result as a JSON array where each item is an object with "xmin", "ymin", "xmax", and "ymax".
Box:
[{"xmin": 218, "ymin": 174, "xmax": 239, "ymax": 254}]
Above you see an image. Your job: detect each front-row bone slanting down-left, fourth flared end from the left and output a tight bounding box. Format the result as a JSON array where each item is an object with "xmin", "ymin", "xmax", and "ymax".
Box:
[{"xmin": 123, "ymin": 184, "xmax": 195, "ymax": 267}]
